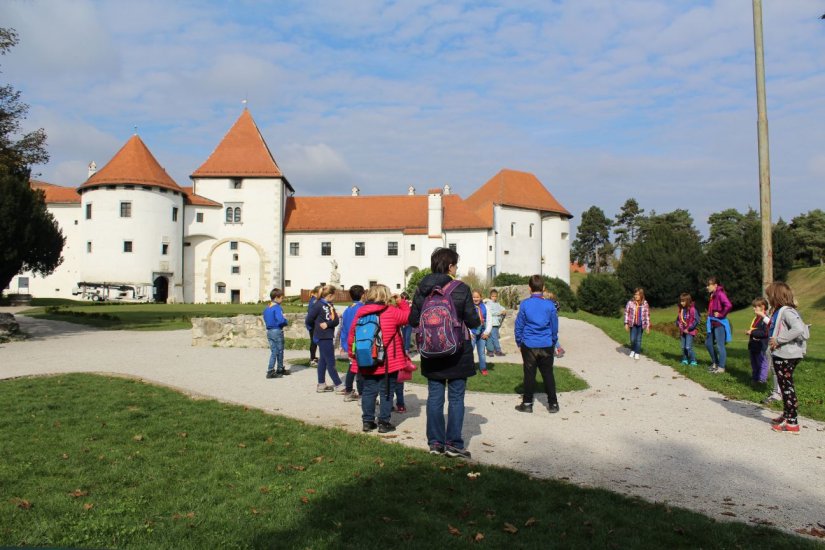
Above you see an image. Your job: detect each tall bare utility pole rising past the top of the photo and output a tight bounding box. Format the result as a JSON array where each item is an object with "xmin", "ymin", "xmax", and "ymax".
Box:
[{"xmin": 753, "ymin": 0, "xmax": 773, "ymax": 290}]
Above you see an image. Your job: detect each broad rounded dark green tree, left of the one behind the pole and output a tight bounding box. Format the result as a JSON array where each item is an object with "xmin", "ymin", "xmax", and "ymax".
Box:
[{"xmin": 616, "ymin": 223, "xmax": 702, "ymax": 307}]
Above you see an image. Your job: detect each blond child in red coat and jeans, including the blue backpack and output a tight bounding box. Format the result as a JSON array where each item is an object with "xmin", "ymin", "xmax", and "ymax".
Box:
[{"xmin": 349, "ymin": 285, "xmax": 410, "ymax": 433}]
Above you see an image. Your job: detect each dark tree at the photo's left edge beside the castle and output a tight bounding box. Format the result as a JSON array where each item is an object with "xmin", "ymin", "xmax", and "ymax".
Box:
[{"xmin": 0, "ymin": 28, "xmax": 66, "ymax": 290}]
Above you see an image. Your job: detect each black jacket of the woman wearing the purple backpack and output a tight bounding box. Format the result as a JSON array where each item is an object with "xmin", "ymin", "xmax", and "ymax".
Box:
[{"xmin": 409, "ymin": 273, "xmax": 481, "ymax": 380}]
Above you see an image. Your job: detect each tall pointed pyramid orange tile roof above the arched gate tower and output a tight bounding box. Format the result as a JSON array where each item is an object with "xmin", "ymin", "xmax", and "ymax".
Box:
[{"xmin": 192, "ymin": 109, "xmax": 283, "ymax": 178}]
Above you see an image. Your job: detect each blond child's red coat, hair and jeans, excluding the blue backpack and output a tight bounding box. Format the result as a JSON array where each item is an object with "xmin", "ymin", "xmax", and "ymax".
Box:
[{"xmin": 349, "ymin": 285, "xmax": 410, "ymax": 433}]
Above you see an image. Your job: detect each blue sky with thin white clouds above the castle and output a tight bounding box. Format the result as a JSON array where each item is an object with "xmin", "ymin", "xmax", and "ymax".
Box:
[{"xmin": 0, "ymin": 0, "xmax": 825, "ymax": 237}]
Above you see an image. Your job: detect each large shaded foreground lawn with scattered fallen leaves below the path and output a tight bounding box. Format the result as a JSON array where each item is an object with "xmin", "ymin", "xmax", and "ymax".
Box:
[{"xmin": 0, "ymin": 374, "xmax": 817, "ymax": 550}]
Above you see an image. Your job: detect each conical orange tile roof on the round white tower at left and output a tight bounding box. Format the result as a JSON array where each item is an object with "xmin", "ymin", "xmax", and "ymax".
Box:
[{"xmin": 78, "ymin": 134, "xmax": 181, "ymax": 192}]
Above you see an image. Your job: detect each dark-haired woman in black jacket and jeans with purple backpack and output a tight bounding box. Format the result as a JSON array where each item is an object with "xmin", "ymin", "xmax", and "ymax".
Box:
[{"xmin": 409, "ymin": 248, "xmax": 481, "ymax": 458}]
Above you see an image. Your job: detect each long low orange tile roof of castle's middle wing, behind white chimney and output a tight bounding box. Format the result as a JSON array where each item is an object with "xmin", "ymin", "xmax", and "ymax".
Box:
[{"xmin": 284, "ymin": 195, "xmax": 491, "ymax": 234}]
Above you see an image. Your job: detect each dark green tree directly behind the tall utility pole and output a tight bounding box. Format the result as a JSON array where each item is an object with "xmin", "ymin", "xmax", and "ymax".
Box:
[{"xmin": 702, "ymin": 209, "xmax": 795, "ymax": 308}]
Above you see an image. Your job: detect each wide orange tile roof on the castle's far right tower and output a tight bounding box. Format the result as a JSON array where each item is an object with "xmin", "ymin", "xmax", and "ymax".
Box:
[{"xmin": 466, "ymin": 169, "xmax": 573, "ymax": 225}]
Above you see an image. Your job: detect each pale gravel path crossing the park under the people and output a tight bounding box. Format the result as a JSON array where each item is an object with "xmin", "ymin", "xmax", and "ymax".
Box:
[{"xmin": 0, "ymin": 309, "xmax": 825, "ymax": 530}]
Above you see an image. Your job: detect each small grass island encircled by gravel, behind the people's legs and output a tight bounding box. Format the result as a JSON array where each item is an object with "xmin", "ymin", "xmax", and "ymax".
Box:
[{"xmin": 290, "ymin": 359, "xmax": 589, "ymax": 394}]
